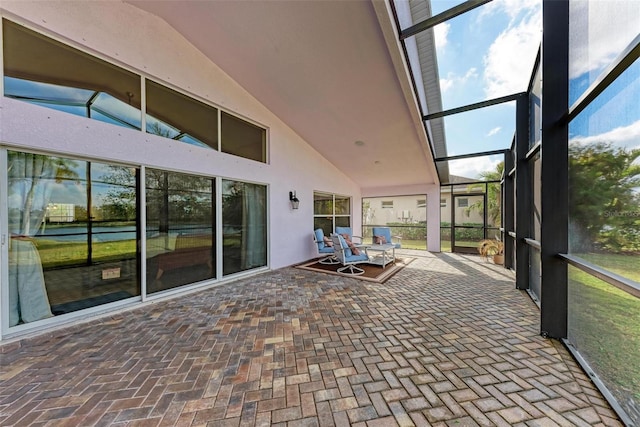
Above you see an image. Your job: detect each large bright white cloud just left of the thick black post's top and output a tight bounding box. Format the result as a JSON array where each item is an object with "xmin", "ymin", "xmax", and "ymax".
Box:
[{"xmin": 484, "ymin": 8, "xmax": 542, "ymax": 98}]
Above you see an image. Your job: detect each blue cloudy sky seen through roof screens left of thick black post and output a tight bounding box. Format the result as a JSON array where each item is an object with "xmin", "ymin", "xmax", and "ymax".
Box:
[{"xmin": 432, "ymin": 0, "xmax": 542, "ymax": 178}]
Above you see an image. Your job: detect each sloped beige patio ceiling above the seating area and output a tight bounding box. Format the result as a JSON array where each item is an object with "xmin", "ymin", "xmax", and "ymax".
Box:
[{"xmin": 127, "ymin": 0, "xmax": 437, "ymax": 189}]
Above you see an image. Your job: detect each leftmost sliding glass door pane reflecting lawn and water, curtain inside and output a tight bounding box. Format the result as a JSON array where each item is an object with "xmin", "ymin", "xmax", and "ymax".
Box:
[{"xmin": 8, "ymin": 151, "xmax": 140, "ymax": 326}]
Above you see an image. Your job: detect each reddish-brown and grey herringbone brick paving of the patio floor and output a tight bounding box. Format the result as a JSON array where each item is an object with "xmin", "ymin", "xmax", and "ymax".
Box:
[{"xmin": 0, "ymin": 252, "xmax": 621, "ymax": 427}]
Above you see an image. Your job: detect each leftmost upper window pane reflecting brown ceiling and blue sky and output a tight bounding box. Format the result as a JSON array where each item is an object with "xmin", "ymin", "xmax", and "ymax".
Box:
[{"xmin": 3, "ymin": 20, "xmax": 141, "ymax": 129}]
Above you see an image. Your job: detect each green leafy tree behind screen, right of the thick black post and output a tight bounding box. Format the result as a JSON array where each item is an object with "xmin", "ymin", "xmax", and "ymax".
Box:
[{"xmin": 569, "ymin": 142, "xmax": 640, "ymax": 252}]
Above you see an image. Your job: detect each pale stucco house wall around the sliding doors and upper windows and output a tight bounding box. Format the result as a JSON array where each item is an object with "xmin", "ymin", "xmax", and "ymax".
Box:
[{"xmin": 0, "ymin": 1, "xmax": 362, "ymax": 268}]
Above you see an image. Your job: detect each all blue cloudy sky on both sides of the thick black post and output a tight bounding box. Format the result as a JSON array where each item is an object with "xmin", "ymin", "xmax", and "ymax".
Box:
[{"xmin": 432, "ymin": 0, "xmax": 640, "ymax": 178}]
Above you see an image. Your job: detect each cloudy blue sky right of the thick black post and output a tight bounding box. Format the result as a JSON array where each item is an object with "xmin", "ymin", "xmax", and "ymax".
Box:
[{"xmin": 569, "ymin": 0, "xmax": 640, "ymax": 159}]
